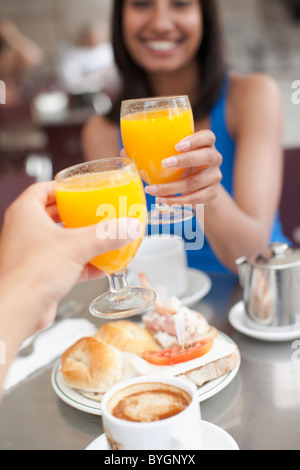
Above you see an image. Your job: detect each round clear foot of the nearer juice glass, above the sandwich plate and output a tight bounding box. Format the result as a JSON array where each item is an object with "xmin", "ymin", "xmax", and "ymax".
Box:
[{"xmin": 90, "ymin": 287, "xmax": 156, "ymax": 320}]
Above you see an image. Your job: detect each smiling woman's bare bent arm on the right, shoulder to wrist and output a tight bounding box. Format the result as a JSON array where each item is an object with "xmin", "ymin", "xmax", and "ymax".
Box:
[{"xmin": 205, "ymin": 76, "xmax": 283, "ymax": 270}]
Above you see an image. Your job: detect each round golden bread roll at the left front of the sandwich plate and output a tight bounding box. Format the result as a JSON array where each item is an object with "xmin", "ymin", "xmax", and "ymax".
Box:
[{"xmin": 61, "ymin": 337, "xmax": 123, "ymax": 391}]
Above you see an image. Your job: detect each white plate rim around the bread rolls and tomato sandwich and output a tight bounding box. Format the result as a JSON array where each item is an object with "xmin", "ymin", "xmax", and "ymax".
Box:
[{"xmin": 51, "ymin": 332, "xmax": 240, "ymax": 416}]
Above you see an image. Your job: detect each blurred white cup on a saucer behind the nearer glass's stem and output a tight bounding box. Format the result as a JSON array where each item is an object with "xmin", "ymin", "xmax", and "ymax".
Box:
[{"xmin": 128, "ymin": 235, "xmax": 188, "ymax": 297}]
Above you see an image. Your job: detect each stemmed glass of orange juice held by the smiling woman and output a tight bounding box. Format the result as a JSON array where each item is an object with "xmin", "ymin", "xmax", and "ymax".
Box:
[{"xmin": 121, "ymin": 96, "xmax": 194, "ymax": 224}]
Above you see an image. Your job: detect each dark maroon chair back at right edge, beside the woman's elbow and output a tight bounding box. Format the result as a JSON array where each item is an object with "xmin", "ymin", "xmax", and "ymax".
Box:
[{"xmin": 280, "ymin": 148, "xmax": 300, "ymax": 247}]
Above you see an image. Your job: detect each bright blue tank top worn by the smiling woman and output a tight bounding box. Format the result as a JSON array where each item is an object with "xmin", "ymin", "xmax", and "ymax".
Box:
[{"xmin": 121, "ymin": 76, "xmax": 290, "ymax": 273}]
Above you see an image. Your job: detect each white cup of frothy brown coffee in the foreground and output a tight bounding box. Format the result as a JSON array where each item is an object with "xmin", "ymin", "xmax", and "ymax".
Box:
[{"xmin": 102, "ymin": 377, "xmax": 203, "ymax": 450}]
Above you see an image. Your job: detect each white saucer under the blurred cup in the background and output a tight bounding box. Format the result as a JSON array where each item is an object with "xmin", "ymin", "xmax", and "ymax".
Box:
[{"xmin": 179, "ymin": 268, "xmax": 211, "ymax": 307}]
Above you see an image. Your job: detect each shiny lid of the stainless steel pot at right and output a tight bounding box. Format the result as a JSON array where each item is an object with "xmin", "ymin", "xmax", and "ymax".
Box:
[{"xmin": 248, "ymin": 242, "xmax": 300, "ymax": 269}]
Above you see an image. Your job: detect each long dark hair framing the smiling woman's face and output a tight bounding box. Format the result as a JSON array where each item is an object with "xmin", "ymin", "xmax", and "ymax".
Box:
[{"xmin": 107, "ymin": 0, "xmax": 225, "ymax": 123}]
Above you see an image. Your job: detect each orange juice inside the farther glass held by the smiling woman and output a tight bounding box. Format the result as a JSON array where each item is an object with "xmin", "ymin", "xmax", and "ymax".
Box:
[{"xmin": 121, "ymin": 108, "xmax": 194, "ymax": 184}]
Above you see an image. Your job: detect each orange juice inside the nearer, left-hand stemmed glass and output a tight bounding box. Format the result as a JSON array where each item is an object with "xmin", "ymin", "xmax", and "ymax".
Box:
[{"xmin": 56, "ymin": 170, "xmax": 147, "ymax": 274}]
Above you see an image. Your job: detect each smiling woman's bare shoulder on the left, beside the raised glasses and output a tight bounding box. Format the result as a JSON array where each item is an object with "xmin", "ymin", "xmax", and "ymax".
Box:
[{"xmin": 82, "ymin": 115, "xmax": 120, "ymax": 160}]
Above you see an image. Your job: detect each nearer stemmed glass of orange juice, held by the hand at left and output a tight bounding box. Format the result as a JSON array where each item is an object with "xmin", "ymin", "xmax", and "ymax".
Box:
[{"xmin": 55, "ymin": 157, "xmax": 156, "ymax": 319}]
